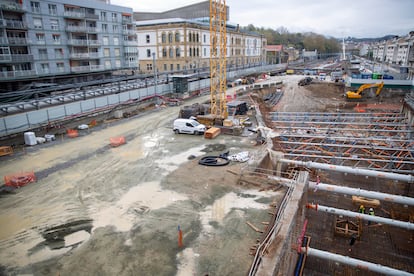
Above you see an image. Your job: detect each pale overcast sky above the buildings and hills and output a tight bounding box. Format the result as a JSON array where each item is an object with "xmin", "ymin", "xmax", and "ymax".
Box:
[{"xmin": 111, "ymin": 0, "xmax": 414, "ymax": 38}]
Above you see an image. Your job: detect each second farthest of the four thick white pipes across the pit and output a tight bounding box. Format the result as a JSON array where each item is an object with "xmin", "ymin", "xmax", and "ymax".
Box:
[{"xmin": 309, "ymin": 182, "xmax": 414, "ymax": 206}]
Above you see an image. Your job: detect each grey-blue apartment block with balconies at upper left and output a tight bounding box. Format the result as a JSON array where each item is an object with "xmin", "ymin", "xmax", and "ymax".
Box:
[{"xmin": 0, "ymin": 0, "xmax": 138, "ymax": 91}]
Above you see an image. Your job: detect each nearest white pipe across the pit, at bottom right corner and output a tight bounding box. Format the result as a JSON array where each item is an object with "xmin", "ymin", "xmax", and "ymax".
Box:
[{"xmin": 302, "ymin": 247, "xmax": 414, "ymax": 276}]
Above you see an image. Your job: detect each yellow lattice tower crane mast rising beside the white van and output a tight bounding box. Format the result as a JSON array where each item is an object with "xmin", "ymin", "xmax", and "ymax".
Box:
[{"xmin": 210, "ymin": 0, "xmax": 228, "ymax": 122}]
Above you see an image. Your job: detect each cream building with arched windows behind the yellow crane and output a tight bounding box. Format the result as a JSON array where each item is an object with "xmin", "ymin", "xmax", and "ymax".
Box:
[{"xmin": 135, "ymin": 18, "xmax": 266, "ymax": 73}]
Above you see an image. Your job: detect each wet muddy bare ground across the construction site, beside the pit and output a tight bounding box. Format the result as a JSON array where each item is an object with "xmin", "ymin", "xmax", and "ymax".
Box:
[{"xmin": 0, "ymin": 76, "xmax": 402, "ymax": 275}]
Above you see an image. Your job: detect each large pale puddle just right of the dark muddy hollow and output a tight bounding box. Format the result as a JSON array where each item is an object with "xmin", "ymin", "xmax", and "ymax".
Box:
[{"xmin": 91, "ymin": 182, "xmax": 187, "ymax": 232}]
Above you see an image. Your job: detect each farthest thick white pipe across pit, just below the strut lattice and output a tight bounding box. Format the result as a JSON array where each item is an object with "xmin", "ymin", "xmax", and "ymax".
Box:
[{"xmin": 278, "ymin": 158, "xmax": 414, "ymax": 183}]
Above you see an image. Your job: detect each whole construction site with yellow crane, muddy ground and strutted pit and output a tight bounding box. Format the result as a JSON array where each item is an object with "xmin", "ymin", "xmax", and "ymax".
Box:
[{"xmin": 0, "ymin": 1, "xmax": 414, "ymax": 276}]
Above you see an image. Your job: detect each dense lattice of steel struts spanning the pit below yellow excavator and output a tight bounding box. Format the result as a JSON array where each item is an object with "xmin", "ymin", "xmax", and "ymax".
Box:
[{"xmin": 270, "ymin": 112, "xmax": 414, "ymax": 173}]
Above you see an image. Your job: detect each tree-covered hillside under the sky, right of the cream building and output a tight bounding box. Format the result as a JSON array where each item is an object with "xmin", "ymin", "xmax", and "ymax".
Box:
[{"xmin": 241, "ymin": 24, "xmax": 341, "ymax": 54}]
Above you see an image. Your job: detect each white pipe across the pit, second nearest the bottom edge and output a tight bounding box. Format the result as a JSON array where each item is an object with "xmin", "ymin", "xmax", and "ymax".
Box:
[{"xmin": 306, "ymin": 203, "xmax": 414, "ymax": 230}]
